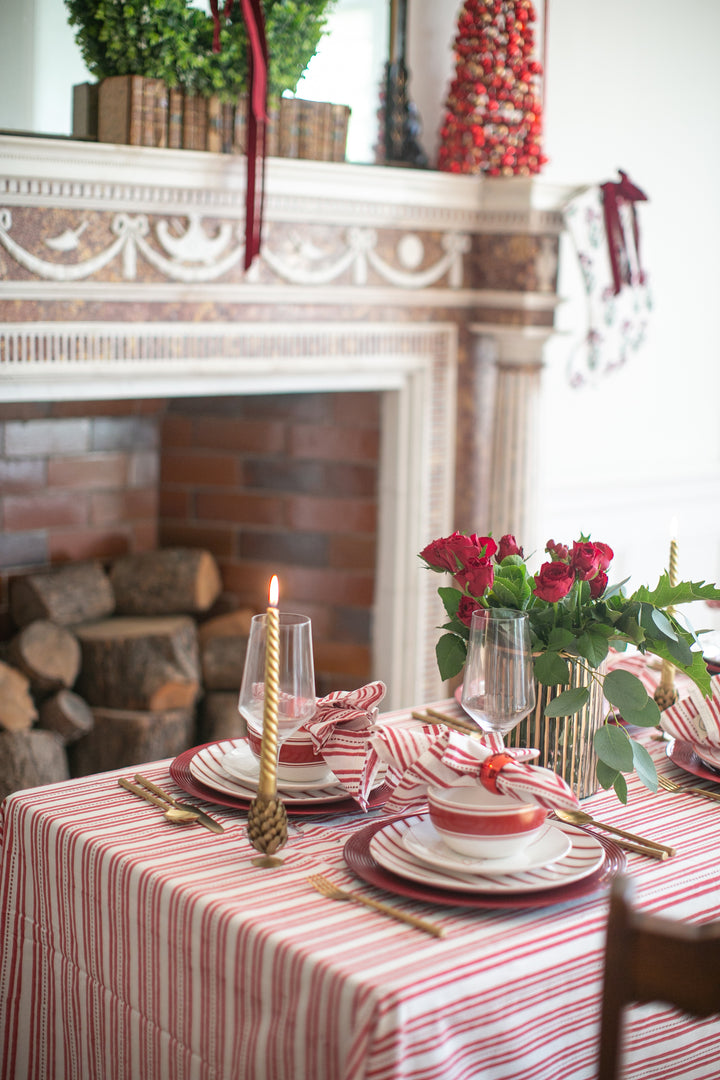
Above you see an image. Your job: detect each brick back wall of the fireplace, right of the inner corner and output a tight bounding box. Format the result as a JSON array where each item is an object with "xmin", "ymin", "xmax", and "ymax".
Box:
[{"xmin": 160, "ymin": 393, "xmax": 380, "ymax": 693}]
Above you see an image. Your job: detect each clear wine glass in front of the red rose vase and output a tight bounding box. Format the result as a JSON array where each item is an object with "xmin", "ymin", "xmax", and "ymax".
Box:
[{"xmin": 461, "ymin": 608, "xmax": 535, "ymax": 734}]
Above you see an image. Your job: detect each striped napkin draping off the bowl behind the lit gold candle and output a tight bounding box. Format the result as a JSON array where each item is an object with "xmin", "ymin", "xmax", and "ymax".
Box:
[{"xmin": 303, "ymin": 680, "xmax": 386, "ymax": 810}]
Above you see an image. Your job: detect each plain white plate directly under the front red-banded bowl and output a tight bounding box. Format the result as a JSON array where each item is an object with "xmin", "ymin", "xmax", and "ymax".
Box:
[{"xmin": 403, "ymin": 818, "xmax": 572, "ymax": 877}]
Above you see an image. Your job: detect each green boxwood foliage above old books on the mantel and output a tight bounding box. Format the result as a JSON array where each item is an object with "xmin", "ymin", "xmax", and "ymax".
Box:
[{"xmin": 65, "ymin": 0, "xmax": 332, "ymax": 99}]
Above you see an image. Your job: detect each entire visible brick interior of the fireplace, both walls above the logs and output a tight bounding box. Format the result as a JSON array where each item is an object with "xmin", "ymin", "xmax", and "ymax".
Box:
[{"xmin": 0, "ymin": 393, "xmax": 380, "ymax": 693}]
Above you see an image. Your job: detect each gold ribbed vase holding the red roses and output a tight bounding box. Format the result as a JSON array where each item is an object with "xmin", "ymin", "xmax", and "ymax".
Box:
[{"xmin": 505, "ymin": 661, "xmax": 606, "ymax": 799}]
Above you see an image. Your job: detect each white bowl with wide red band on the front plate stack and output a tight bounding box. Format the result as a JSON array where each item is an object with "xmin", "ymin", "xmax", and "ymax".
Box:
[{"xmin": 427, "ymin": 784, "xmax": 548, "ymax": 859}]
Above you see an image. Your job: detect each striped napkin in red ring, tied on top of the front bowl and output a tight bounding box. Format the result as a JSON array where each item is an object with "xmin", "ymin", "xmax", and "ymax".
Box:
[{"xmin": 372, "ymin": 725, "xmax": 580, "ymax": 813}]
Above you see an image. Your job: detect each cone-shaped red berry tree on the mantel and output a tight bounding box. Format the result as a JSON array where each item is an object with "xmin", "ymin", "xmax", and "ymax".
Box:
[{"xmin": 438, "ymin": 0, "xmax": 546, "ymax": 176}]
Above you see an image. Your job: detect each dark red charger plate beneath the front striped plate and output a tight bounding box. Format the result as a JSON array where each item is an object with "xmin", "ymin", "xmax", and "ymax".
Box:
[{"xmin": 343, "ymin": 814, "xmax": 627, "ymax": 908}]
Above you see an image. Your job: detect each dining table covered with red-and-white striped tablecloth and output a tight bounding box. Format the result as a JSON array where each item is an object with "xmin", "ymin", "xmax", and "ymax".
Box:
[{"xmin": 0, "ymin": 701, "xmax": 720, "ymax": 1080}]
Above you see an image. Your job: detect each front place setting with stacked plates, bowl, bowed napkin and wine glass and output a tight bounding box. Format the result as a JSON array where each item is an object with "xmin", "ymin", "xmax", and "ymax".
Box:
[{"xmin": 344, "ymin": 611, "xmax": 630, "ymax": 907}]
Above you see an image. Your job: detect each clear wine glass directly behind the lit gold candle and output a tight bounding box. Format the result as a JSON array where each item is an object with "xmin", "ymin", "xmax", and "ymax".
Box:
[{"xmin": 237, "ymin": 611, "xmax": 316, "ymax": 745}]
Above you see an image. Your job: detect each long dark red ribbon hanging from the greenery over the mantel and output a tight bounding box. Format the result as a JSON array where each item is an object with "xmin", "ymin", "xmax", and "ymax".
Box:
[{"xmin": 210, "ymin": 0, "xmax": 268, "ymax": 270}]
